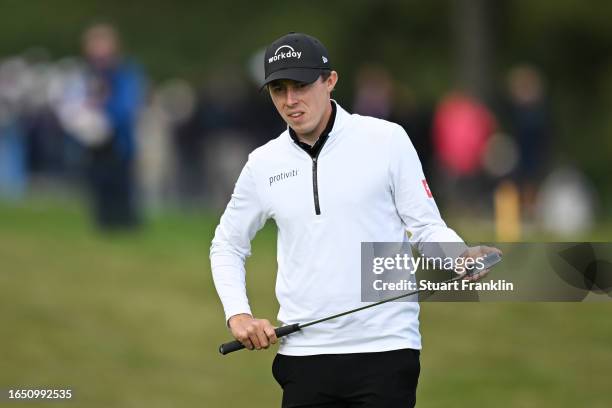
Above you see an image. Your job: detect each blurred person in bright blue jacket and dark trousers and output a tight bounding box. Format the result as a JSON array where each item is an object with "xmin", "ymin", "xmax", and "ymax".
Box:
[{"xmin": 83, "ymin": 24, "xmax": 144, "ymax": 228}]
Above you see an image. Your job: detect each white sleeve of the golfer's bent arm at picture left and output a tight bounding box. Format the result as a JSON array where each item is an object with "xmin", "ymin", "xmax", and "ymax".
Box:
[{"xmin": 210, "ymin": 159, "xmax": 267, "ymax": 322}]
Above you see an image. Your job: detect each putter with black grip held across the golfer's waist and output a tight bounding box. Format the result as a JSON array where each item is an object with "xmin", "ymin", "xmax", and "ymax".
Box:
[{"xmin": 219, "ymin": 252, "xmax": 502, "ymax": 355}]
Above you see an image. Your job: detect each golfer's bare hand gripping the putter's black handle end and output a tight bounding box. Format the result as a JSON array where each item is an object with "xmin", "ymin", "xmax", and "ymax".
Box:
[{"xmin": 228, "ymin": 313, "xmax": 277, "ymax": 350}]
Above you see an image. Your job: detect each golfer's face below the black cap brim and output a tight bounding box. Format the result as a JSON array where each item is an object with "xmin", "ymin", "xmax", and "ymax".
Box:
[{"xmin": 269, "ymin": 76, "xmax": 335, "ymax": 136}]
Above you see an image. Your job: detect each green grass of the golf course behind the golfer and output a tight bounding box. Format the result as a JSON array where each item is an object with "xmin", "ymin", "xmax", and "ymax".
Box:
[{"xmin": 0, "ymin": 201, "xmax": 612, "ymax": 408}]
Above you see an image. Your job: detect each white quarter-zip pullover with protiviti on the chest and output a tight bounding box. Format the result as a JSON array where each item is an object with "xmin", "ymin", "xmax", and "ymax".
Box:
[{"xmin": 210, "ymin": 102, "xmax": 462, "ymax": 355}]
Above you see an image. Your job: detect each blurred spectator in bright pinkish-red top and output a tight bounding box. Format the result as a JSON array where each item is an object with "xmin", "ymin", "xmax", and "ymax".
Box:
[{"xmin": 432, "ymin": 92, "xmax": 497, "ymax": 204}]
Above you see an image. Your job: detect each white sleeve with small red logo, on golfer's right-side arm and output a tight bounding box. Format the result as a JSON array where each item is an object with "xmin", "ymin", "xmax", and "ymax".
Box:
[{"xmin": 389, "ymin": 125, "xmax": 467, "ymax": 257}]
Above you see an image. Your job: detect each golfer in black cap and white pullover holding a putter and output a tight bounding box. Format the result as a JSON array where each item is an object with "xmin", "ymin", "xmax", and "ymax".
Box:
[{"xmin": 211, "ymin": 33, "xmax": 500, "ymax": 407}]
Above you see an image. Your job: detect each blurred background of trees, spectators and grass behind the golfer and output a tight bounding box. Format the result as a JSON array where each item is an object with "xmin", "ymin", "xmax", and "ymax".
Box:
[{"xmin": 0, "ymin": 0, "xmax": 612, "ymax": 407}]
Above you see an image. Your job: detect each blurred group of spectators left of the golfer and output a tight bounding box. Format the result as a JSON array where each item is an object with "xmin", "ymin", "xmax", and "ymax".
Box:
[{"xmin": 0, "ymin": 24, "xmax": 284, "ymax": 228}]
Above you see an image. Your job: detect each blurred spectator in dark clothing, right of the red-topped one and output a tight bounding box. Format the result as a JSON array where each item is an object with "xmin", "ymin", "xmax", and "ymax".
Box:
[{"xmin": 507, "ymin": 65, "xmax": 550, "ymax": 216}]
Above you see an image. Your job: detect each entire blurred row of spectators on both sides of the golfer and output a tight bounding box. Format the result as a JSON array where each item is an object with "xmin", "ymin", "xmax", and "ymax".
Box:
[{"xmin": 0, "ymin": 24, "xmax": 594, "ymax": 239}]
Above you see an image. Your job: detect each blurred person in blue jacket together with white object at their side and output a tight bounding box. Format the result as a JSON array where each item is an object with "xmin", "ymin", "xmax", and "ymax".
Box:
[{"xmin": 59, "ymin": 24, "xmax": 143, "ymax": 228}]
